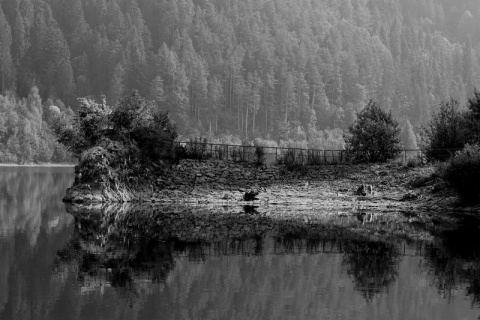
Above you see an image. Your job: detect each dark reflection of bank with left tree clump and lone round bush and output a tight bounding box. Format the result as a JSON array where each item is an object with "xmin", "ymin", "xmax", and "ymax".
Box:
[{"xmin": 57, "ymin": 207, "xmax": 399, "ymax": 301}]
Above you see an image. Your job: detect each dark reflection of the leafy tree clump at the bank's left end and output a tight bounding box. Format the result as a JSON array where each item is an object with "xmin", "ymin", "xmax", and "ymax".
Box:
[{"xmin": 55, "ymin": 215, "xmax": 175, "ymax": 300}]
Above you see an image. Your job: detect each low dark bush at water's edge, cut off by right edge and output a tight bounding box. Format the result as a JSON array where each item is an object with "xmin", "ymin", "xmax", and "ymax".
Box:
[{"xmin": 441, "ymin": 144, "xmax": 480, "ymax": 202}]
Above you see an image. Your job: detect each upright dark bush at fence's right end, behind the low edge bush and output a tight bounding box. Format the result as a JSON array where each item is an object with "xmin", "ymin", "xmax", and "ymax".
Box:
[{"xmin": 422, "ymin": 99, "xmax": 469, "ymax": 161}]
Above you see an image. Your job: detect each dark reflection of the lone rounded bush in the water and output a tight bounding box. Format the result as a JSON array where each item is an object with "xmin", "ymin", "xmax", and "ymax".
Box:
[{"xmin": 343, "ymin": 241, "xmax": 399, "ymax": 301}]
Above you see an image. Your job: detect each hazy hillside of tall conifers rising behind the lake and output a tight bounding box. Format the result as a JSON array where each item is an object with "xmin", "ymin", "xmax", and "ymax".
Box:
[{"xmin": 0, "ymin": 0, "xmax": 480, "ymax": 155}]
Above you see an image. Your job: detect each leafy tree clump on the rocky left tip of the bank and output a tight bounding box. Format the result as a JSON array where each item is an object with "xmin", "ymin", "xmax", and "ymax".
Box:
[{"xmin": 54, "ymin": 92, "xmax": 177, "ymax": 183}]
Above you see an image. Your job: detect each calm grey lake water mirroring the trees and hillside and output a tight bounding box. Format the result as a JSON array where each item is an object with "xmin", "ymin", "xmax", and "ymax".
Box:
[{"xmin": 0, "ymin": 167, "xmax": 480, "ymax": 320}]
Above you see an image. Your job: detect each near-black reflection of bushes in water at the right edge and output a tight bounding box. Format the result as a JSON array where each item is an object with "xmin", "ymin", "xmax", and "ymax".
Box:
[{"xmin": 426, "ymin": 218, "xmax": 480, "ymax": 305}]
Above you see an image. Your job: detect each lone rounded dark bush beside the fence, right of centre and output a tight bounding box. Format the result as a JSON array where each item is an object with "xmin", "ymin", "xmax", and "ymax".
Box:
[{"xmin": 344, "ymin": 101, "xmax": 401, "ymax": 162}]
